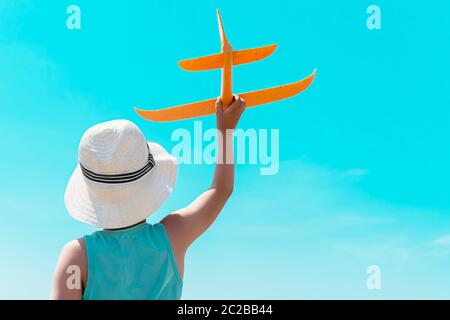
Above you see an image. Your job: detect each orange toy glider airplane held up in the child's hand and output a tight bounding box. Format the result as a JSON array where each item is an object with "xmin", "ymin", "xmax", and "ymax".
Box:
[{"xmin": 135, "ymin": 10, "xmax": 316, "ymax": 122}]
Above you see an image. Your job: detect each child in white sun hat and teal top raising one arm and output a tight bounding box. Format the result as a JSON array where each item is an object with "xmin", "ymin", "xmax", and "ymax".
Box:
[{"xmin": 51, "ymin": 96, "xmax": 245, "ymax": 300}]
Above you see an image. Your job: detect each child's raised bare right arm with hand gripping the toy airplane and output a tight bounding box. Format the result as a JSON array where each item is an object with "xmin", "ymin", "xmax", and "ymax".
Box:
[{"xmin": 161, "ymin": 96, "xmax": 245, "ymax": 273}]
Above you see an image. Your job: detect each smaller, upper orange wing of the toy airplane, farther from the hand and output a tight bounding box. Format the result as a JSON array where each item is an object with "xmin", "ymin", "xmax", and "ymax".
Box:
[{"xmin": 178, "ymin": 44, "xmax": 277, "ymax": 71}]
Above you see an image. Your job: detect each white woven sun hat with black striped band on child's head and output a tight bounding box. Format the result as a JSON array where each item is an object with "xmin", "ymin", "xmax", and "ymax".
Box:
[{"xmin": 64, "ymin": 120, "xmax": 177, "ymax": 229}]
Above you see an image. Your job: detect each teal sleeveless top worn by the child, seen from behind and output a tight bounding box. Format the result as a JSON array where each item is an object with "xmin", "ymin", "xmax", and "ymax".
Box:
[{"xmin": 83, "ymin": 223, "xmax": 183, "ymax": 300}]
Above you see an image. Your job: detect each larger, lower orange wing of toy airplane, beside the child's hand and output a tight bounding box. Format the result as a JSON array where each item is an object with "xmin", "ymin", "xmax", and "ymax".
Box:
[{"xmin": 135, "ymin": 70, "xmax": 316, "ymax": 122}]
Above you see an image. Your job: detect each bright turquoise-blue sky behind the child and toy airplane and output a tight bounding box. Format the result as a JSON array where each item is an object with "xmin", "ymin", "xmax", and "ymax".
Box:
[{"xmin": 0, "ymin": 0, "xmax": 450, "ymax": 299}]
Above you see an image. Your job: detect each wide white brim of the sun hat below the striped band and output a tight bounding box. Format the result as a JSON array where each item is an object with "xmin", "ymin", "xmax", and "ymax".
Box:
[{"xmin": 64, "ymin": 142, "xmax": 177, "ymax": 229}]
